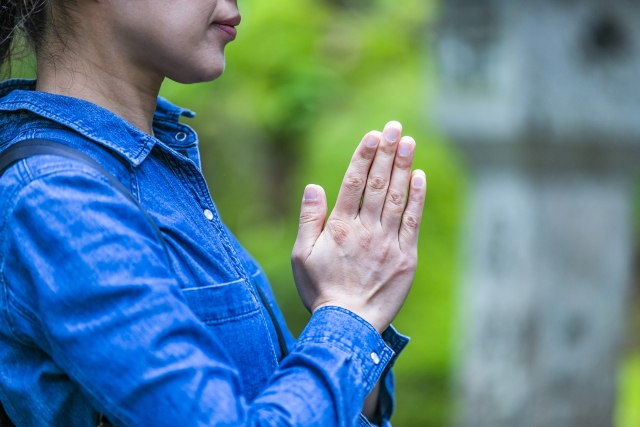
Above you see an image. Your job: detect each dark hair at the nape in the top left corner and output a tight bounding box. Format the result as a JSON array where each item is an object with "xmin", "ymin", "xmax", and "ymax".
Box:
[{"xmin": 0, "ymin": 0, "xmax": 51, "ymax": 73}]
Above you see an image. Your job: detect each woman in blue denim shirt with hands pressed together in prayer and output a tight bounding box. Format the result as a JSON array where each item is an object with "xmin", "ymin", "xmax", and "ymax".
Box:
[{"xmin": 0, "ymin": 0, "xmax": 426, "ymax": 427}]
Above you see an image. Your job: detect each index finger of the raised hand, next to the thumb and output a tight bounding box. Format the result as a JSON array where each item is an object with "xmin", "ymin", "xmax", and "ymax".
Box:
[{"xmin": 333, "ymin": 131, "xmax": 382, "ymax": 218}]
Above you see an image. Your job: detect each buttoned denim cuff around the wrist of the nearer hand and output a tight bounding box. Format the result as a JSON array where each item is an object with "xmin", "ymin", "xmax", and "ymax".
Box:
[{"xmin": 296, "ymin": 306, "xmax": 396, "ymax": 395}]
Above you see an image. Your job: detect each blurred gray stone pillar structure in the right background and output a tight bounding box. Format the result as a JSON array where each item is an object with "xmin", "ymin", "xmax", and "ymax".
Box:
[{"xmin": 437, "ymin": 0, "xmax": 640, "ymax": 427}]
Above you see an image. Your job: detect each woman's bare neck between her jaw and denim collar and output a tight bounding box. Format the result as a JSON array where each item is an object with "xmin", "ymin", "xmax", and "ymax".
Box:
[{"xmin": 36, "ymin": 31, "xmax": 163, "ymax": 135}]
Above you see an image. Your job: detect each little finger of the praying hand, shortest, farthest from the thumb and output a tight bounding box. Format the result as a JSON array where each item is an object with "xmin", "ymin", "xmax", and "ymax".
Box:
[{"xmin": 398, "ymin": 170, "xmax": 427, "ymax": 253}]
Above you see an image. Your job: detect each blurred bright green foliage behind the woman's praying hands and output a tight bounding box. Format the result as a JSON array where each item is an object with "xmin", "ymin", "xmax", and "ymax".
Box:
[{"xmin": 162, "ymin": 0, "xmax": 640, "ymax": 427}]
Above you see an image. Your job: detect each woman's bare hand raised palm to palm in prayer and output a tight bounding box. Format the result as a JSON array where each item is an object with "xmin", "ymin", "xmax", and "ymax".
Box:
[{"xmin": 291, "ymin": 122, "xmax": 427, "ymax": 333}]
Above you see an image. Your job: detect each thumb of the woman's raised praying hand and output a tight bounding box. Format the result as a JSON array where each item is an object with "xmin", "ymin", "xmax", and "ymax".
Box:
[{"xmin": 291, "ymin": 185, "xmax": 327, "ymax": 263}]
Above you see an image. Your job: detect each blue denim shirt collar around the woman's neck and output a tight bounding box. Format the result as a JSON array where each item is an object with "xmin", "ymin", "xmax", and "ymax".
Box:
[{"xmin": 0, "ymin": 79, "xmax": 195, "ymax": 166}]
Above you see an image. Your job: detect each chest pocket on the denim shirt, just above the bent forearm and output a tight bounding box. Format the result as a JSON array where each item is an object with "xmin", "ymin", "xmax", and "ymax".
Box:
[{"xmin": 181, "ymin": 279, "xmax": 277, "ymax": 402}]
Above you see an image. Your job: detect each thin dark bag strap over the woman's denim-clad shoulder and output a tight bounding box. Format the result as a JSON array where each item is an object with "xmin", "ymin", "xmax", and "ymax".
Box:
[{"xmin": 0, "ymin": 139, "xmax": 172, "ymax": 268}]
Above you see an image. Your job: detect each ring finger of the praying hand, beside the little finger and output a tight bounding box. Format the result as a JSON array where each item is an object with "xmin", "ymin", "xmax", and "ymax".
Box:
[{"xmin": 382, "ymin": 136, "xmax": 416, "ymax": 230}]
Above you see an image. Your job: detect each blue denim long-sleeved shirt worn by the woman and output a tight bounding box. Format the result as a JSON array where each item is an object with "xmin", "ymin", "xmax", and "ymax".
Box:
[{"xmin": 0, "ymin": 80, "xmax": 408, "ymax": 427}]
